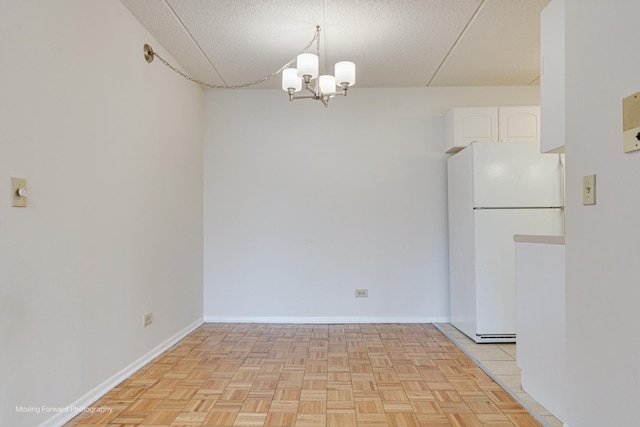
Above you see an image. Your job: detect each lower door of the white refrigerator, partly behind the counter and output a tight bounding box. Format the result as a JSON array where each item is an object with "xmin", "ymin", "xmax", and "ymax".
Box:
[{"xmin": 474, "ymin": 209, "xmax": 562, "ymax": 341}]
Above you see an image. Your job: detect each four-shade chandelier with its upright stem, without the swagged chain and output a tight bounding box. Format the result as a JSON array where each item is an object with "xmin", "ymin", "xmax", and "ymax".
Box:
[{"xmin": 282, "ymin": 25, "xmax": 356, "ymax": 107}]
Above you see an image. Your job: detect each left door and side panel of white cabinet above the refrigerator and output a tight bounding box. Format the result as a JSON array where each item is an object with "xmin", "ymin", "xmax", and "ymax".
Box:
[{"xmin": 445, "ymin": 107, "xmax": 498, "ymax": 153}]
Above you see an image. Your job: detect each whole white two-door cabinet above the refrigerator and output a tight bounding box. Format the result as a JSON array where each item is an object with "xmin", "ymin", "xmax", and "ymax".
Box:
[{"xmin": 445, "ymin": 107, "xmax": 540, "ymax": 153}]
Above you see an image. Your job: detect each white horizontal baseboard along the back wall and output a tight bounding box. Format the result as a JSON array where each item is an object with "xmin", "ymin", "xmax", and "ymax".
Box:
[{"xmin": 204, "ymin": 316, "xmax": 449, "ymax": 324}]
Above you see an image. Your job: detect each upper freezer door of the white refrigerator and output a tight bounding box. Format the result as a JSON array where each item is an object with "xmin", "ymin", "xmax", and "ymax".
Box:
[{"xmin": 471, "ymin": 142, "xmax": 564, "ymax": 208}]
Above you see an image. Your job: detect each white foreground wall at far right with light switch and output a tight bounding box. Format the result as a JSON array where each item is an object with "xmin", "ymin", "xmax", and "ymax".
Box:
[{"xmin": 565, "ymin": 0, "xmax": 640, "ymax": 427}]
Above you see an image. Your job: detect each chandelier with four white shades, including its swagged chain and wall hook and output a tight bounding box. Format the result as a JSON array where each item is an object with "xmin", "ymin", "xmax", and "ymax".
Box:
[{"xmin": 143, "ymin": 25, "xmax": 356, "ymax": 107}]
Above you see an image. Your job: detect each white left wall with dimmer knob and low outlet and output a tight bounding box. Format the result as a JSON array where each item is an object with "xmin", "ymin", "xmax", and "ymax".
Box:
[{"xmin": 0, "ymin": 0, "xmax": 202, "ymax": 427}]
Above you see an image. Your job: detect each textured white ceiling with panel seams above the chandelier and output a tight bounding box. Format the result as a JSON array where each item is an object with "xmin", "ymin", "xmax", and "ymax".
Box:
[{"xmin": 121, "ymin": 0, "xmax": 550, "ymax": 89}]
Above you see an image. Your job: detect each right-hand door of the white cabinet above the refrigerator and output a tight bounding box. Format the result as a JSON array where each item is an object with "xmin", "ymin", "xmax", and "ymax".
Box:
[{"xmin": 498, "ymin": 107, "xmax": 540, "ymax": 142}]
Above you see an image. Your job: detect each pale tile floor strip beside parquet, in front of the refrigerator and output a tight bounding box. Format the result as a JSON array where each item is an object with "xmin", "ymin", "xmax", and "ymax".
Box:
[{"xmin": 434, "ymin": 323, "xmax": 563, "ymax": 427}]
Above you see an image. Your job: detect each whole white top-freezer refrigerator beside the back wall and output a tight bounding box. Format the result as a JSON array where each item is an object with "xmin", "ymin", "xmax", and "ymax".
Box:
[{"xmin": 447, "ymin": 142, "xmax": 564, "ymax": 343}]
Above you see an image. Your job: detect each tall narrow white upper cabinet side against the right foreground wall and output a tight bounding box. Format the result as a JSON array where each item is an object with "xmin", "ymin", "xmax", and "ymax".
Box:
[{"xmin": 540, "ymin": 0, "xmax": 565, "ymax": 153}]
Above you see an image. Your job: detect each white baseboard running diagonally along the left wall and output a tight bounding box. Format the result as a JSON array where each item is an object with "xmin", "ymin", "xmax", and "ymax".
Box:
[{"xmin": 38, "ymin": 318, "xmax": 204, "ymax": 427}]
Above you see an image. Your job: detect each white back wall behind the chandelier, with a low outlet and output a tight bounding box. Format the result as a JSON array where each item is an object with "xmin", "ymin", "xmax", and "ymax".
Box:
[{"xmin": 204, "ymin": 86, "xmax": 539, "ymax": 322}]
